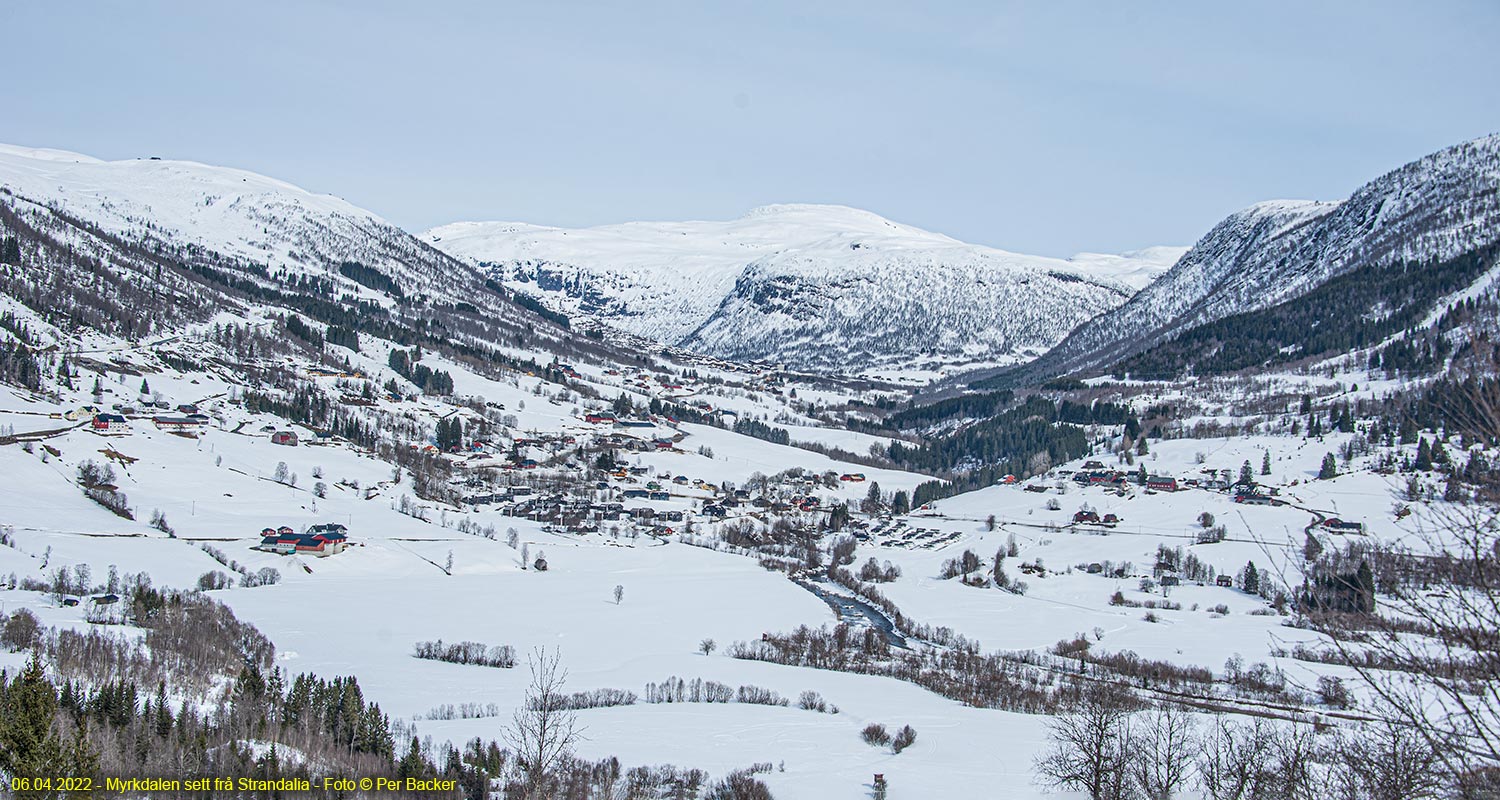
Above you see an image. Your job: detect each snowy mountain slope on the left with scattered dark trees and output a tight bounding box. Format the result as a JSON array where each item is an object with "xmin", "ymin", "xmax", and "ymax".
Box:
[{"xmin": 0, "ymin": 146, "xmax": 636, "ymax": 367}]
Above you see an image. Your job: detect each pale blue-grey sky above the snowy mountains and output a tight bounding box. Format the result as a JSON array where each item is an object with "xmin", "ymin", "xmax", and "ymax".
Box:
[{"xmin": 0, "ymin": 0, "xmax": 1500, "ymax": 257}]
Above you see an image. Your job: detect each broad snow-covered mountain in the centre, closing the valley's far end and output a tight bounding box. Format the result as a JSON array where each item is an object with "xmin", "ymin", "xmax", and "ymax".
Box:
[{"xmin": 423, "ymin": 204, "xmax": 1182, "ymax": 372}]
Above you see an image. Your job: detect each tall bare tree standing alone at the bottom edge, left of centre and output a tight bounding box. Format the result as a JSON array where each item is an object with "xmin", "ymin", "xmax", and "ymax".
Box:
[{"xmin": 504, "ymin": 647, "xmax": 584, "ymax": 798}]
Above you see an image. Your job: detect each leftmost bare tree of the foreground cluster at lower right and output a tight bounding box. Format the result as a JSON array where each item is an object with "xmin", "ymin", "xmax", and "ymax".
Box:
[{"xmin": 1037, "ymin": 683, "xmax": 1134, "ymax": 800}]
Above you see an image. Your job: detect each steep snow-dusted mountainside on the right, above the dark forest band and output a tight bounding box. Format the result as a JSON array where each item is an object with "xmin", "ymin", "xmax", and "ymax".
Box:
[{"xmin": 1022, "ymin": 135, "xmax": 1500, "ymax": 378}]
